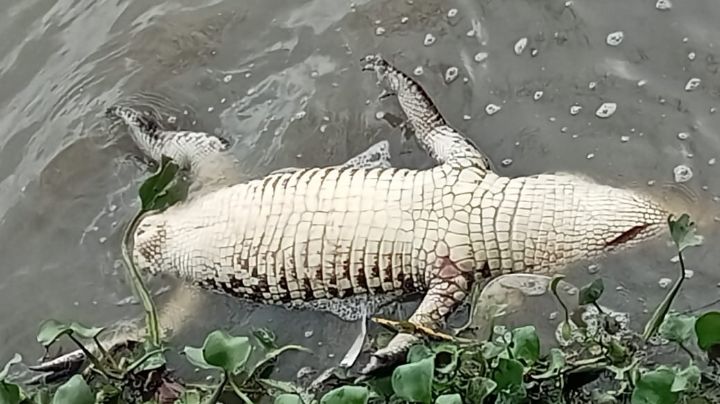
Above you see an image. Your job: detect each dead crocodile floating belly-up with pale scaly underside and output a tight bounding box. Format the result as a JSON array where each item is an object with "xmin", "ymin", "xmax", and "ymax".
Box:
[{"xmin": 33, "ymin": 54, "xmax": 670, "ymax": 374}]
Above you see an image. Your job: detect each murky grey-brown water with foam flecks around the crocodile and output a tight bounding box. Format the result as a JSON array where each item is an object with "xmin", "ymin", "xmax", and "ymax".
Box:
[{"xmin": 0, "ymin": 0, "xmax": 720, "ymax": 378}]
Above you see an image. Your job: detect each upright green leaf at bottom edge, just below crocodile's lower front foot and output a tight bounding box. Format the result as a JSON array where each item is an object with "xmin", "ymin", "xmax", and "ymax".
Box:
[{"xmin": 392, "ymin": 358, "xmax": 435, "ymax": 403}]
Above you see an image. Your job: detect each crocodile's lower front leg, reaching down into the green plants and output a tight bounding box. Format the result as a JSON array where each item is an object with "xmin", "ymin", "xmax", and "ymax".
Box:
[{"xmin": 361, "ymin": 257, "xmax": 473, "ymax": 374}]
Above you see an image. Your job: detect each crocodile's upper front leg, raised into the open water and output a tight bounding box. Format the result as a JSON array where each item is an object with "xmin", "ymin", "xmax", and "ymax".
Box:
[{"xmin": 362, "ymin": 54, "xmax": 493, "ymax": 171}]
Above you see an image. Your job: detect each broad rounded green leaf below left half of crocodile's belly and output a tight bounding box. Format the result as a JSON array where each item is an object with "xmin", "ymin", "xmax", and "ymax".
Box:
[{"xmin": 202, "ymin": 330, "xmax": 253, "ymax": 374}]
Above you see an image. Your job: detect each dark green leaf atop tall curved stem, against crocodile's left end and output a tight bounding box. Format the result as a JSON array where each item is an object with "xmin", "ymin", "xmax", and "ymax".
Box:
[{"xmin": 139, "ymin": 156, "xmax": 190, "ymax": 212}]
